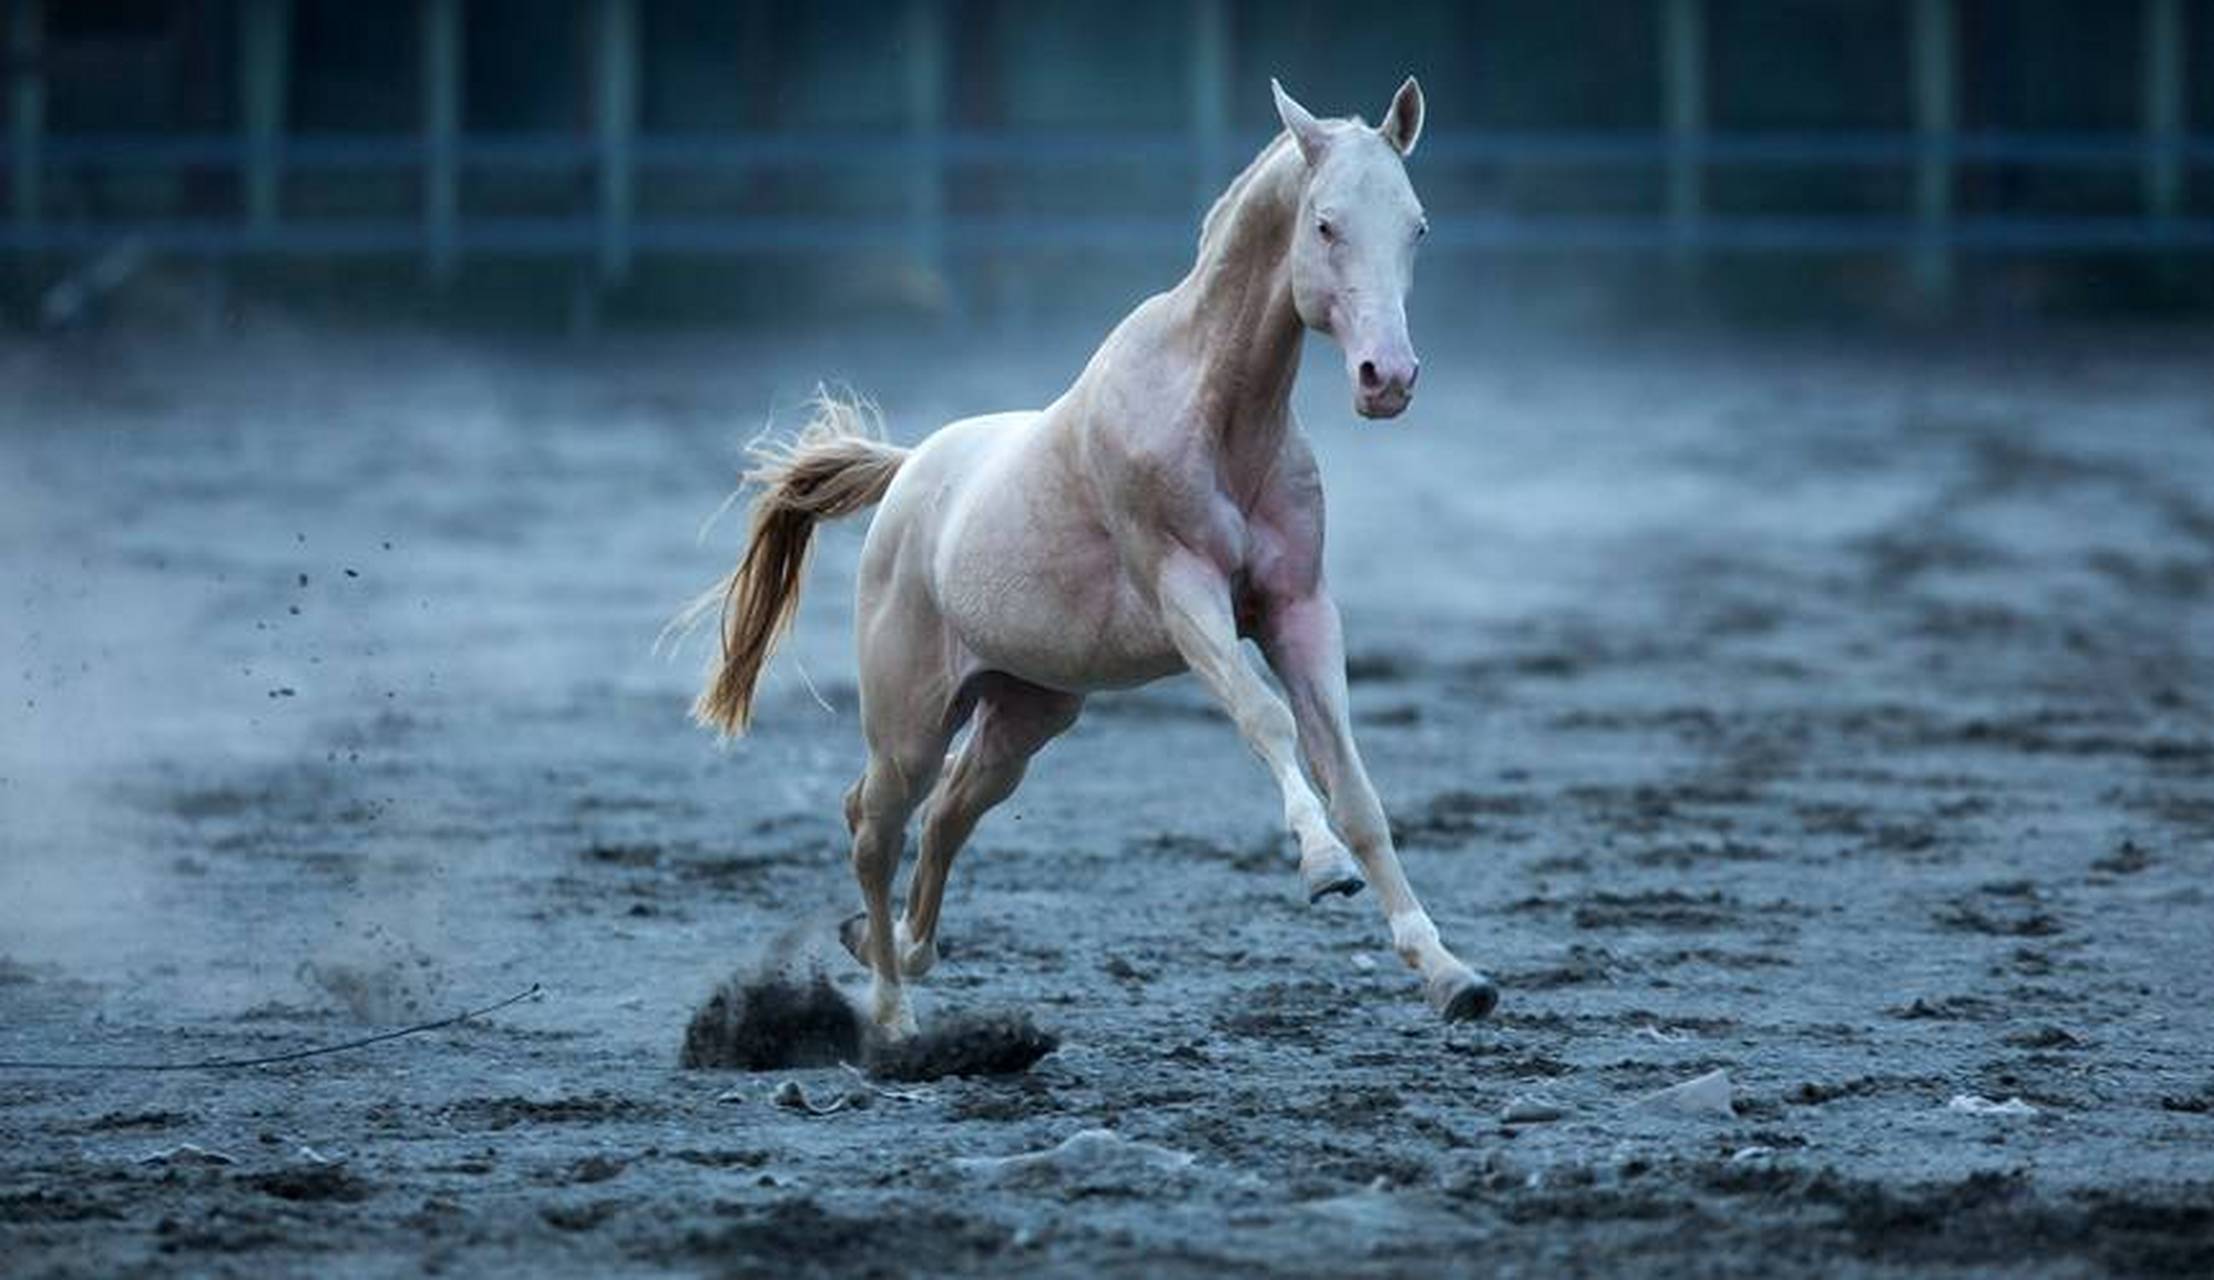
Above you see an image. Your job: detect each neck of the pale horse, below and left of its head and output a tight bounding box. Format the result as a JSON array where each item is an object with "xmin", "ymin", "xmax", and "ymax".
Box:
[{"xmin": 1178, "ymin": 146, "xmax": 1302, "ymax": 487}]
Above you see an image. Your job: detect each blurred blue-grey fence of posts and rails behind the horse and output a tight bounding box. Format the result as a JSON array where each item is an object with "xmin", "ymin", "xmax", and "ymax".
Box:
[{"xmin": 0, "ymin": 0, "xmax": 2214, "ymax": 307}]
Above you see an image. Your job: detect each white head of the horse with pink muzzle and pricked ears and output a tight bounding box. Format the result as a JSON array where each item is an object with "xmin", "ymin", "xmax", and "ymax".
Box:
[{"xmin": 1269, "ymin": 75, "xmax": 1428, "ymax": 419}]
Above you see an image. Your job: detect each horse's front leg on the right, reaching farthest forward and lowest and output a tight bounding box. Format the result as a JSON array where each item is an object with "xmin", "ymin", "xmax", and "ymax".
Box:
[{"xmin": 1260, "ymin": 589, "xmax": 1499, "ymax": 1021}]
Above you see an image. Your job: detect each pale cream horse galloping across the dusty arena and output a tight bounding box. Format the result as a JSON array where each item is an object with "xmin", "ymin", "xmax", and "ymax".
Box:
[{"xmin": 695, "ymin": 78, "xmax": 1497, "ymax": 1036}]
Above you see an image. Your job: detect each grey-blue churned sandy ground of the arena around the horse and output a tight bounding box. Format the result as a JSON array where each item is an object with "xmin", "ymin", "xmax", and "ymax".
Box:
[{"xmin": 0, "ymin": 323, "xmax": 2214, "ymax": 1276}]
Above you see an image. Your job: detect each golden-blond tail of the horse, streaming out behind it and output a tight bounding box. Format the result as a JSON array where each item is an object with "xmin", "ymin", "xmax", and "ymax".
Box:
[{"xmin": 675, "ymin": 392, "xmax": 908, "ymax": 737}]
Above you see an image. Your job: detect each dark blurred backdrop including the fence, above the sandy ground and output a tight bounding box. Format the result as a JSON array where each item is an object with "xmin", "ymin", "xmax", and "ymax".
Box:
[{"xmin": 13, "ymin": 0, "xmax": 2214, "ymax": 330}]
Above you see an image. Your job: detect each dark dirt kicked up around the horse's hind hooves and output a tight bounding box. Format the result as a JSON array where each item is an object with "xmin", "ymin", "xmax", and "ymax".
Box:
[{"xmin": 677, "ymin": 968, "xmax": 1061, "ymax": 1081}]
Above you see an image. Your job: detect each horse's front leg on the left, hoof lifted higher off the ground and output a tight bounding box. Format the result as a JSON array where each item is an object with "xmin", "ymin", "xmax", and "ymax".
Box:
[{"xmin": 1158, "ymin": 554, "xmax": 1362, "ymax": 901}]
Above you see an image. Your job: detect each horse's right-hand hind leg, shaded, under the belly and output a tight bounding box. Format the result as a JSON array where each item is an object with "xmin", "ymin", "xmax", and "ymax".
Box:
[{"xmin": 897, "ymin": 673, "xmax": 1085, "ymax": 979}]
